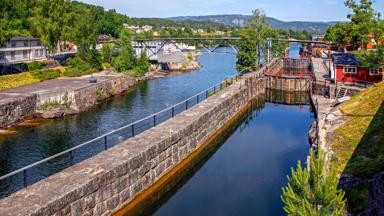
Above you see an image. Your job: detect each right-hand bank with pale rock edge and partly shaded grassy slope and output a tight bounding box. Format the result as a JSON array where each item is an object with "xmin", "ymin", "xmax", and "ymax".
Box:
[{"xmin": 311, "ymin": 83, "xmax": 384, "ymax": 215}]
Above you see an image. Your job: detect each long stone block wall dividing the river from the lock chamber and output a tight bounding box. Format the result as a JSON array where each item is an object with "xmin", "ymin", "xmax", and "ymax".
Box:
[{"xmin": 0, "ymin": 73, "xmax": 265, "ymax": 216}]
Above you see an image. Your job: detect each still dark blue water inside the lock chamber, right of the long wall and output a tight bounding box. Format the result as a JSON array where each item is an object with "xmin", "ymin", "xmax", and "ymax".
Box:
[{"xmin": 145, "ymin": 98, "xmax": 313, "ymax": 215}]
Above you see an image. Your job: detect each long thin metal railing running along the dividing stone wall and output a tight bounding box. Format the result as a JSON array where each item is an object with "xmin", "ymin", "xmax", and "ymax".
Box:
[{"xmin": 0, "ymin": 75, "xmax": 239, "ymax": 197}]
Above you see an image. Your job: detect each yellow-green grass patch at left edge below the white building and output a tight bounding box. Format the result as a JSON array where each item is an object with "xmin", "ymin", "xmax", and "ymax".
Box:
[{"xmin": 0, "ymin": 72, "xmax": 40, "ymax": 90}]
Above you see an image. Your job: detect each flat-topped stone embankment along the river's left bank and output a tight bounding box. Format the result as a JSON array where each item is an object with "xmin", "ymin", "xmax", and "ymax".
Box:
[{"xmin": 0, "ymin": 74, "xmax": 136, "ymax": 128}]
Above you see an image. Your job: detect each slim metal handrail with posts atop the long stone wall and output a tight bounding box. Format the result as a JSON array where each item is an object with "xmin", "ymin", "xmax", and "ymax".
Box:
[{"xmin": 0, "ymin": 75, "xmax": 239, "ymax": 198}]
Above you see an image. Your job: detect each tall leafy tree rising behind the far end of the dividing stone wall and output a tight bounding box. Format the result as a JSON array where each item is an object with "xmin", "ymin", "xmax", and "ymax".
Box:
[{"xmin": 236, "ymin": 9, "xmax": 286, "ymax": 72}]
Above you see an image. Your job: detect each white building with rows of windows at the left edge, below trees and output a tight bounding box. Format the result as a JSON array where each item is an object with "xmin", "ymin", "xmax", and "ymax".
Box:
[{"xmin": 0, "ymin": 37, "xmax": 47, "ymax": 64}]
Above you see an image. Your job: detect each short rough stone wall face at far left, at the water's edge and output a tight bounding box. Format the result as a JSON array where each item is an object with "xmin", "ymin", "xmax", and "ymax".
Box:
[{"xmin": 0, "ymin": 95, "xmax": 38, "ymax": 128}]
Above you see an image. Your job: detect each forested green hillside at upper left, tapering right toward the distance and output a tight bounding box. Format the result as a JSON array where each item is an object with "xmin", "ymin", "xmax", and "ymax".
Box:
[{"xmin": 0, "ymin": 0, "xmax": 230, "ymax": 50}]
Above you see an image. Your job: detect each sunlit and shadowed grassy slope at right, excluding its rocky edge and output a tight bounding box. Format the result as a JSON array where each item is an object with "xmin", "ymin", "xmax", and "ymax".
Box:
[{"xmin": 332, "ymin": 83, "xmax": 384, "ymax": 213}]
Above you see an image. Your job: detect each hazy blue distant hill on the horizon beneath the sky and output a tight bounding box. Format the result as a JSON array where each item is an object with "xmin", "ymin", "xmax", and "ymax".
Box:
[{"xmin": 168, "ymin": 14, "xmax": 336, "ymax": 33}]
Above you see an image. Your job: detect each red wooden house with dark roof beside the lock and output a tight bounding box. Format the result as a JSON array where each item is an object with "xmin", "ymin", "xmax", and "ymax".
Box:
[{"xmin": 331, "ymin": 53, "xmax": 383, "ymax": 84}]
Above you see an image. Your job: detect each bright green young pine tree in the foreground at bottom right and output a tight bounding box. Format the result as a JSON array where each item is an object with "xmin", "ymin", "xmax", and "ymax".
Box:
[{"xmin": 282, "ymin": 150, "xmax": 347, "ymax": 216}]
